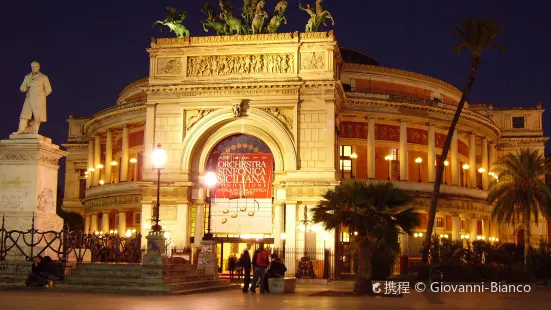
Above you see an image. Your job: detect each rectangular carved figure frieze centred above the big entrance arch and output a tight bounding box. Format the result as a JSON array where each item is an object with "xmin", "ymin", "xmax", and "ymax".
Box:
[{"xmin": 187, "ymin": 54, "xmax": 294, "ymax": 77}]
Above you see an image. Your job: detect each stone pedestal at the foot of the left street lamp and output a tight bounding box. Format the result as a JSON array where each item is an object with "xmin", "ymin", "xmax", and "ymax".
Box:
[{"xmin": 142, "ymin": 234, "xmax": 168, "ymax": 282}]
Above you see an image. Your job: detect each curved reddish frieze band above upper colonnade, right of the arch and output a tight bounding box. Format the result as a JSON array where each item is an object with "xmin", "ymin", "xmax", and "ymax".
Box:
[{"xmin": 347, "ymin": 98, "xmax": 501, "ymax": 137}]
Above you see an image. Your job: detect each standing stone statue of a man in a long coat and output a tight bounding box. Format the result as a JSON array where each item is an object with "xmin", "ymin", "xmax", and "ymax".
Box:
[{"xmin": 17, "ymin": 61, "xmax": 52, "ymax": 134}]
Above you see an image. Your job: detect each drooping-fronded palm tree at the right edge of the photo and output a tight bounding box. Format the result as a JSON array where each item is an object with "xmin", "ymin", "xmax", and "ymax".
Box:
[{"xmin": 488, "ymin": 149, "xmax": 551, "ymax": 269}]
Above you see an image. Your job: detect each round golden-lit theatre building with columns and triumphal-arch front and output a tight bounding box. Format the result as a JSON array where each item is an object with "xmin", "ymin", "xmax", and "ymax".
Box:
[{"xmin": 63, "ymin": 32, "xmax": 549, "ymax": 274}]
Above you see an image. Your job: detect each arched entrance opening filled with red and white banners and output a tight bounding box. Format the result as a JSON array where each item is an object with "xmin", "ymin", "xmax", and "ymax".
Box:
[{"xmin": 205, "ymin": 134, "xmax": 274, "ymax": 272}]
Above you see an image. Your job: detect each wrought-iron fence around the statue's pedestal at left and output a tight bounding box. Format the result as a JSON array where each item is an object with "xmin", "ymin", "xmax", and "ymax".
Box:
[{"xmin": 0, "ymin": 216, "xmax": 141, "ymax": 263}]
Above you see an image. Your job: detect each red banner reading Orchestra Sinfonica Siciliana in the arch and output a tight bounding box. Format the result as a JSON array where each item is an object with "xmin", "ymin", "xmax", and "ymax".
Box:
[{"xmin": 214, "ymin": 153, "xmax": 274, "ymax": 198}]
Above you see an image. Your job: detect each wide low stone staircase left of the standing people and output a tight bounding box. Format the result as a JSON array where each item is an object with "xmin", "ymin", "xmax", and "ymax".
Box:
[{"xmin": 54, "ymin": 263, "xmax": 239, "ymax": 294}]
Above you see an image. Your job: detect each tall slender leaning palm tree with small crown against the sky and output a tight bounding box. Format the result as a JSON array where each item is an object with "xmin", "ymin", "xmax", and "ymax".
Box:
[{"xmin": 423, "ymin": 18, "xmax": 505, "ymax": 263}]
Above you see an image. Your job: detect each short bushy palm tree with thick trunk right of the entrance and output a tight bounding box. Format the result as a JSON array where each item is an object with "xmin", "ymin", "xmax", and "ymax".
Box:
[{"xmin": 313, "ymin": 180, "xmax": 419, "ymax": 293}]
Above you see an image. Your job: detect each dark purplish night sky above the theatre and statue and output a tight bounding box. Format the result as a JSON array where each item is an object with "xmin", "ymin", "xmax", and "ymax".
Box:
[{"xmin": 0, "ymin": 0, "xmax": 551, "ymax": 149}]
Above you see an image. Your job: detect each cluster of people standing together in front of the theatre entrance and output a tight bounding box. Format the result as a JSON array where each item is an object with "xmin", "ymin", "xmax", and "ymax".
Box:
[{"xmin": 237, "ymin": 242, "xmax": 287, "ymax": 294}]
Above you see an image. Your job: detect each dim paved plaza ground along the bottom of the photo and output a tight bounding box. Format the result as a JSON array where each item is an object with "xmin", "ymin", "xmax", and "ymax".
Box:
[{"xmin": 0, "ymin": 283, "xmax": 551, "ymax": 310}]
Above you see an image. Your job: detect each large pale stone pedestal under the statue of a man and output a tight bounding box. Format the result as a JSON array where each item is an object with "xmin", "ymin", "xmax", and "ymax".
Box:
[{"xmin": 0, "ymin": 133, "xmax": 67, "ymax": 259}]
